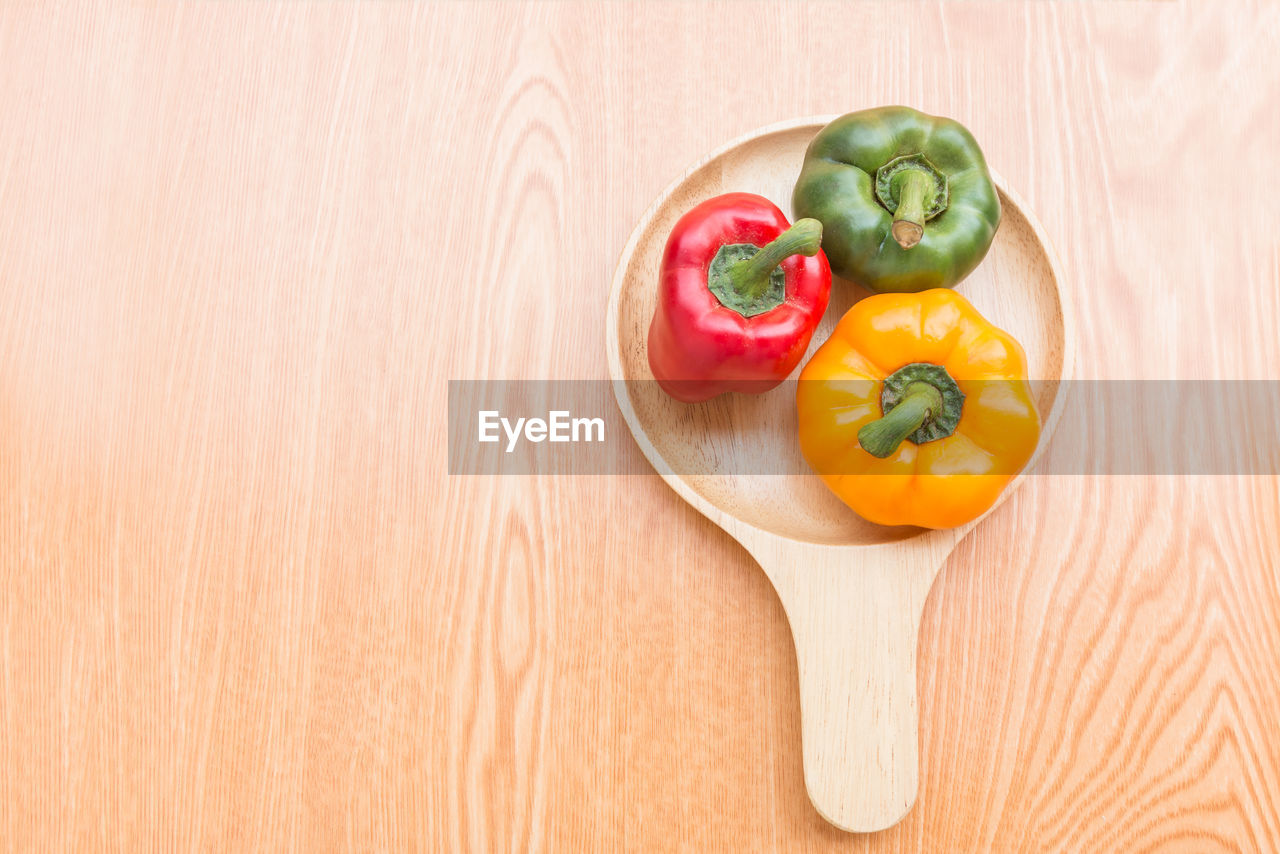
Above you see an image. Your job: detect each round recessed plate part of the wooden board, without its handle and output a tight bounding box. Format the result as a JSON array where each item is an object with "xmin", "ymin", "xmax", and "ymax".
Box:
[{"xmin": 607, "ymin": 117, "xmax": 1073, "ymax": 545}]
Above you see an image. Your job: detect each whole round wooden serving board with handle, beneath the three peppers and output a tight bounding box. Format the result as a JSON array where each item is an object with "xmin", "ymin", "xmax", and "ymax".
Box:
[{"xmin": 605, "ymin": 117, "xmax": 1075, "ymax": 832}]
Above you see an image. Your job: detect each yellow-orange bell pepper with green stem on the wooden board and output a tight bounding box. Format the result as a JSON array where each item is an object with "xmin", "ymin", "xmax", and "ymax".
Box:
[{"xmin": 796, "ymin": 289, "xmax": 1041, "ymax": 528}]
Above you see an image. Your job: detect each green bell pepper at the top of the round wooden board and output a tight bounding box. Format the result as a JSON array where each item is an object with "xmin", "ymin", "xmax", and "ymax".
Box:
[{"xmin": 791, "ymin": 106, "xmax": 1000, "ymax": 293}]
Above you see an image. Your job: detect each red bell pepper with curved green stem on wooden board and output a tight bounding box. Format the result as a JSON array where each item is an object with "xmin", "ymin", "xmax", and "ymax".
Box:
[{"xmin": 649, "ymin": 193, "xmax": 831, "ymax": 402}]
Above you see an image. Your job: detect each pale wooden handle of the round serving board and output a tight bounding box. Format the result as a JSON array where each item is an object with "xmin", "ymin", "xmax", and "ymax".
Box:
[{"xmin": 749, "ymin": 536, "xmax": 946, "ymax": 832}]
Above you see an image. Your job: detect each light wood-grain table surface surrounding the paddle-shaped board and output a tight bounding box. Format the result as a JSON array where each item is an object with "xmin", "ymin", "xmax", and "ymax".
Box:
[{"xmin": 0, "ymin": 0, "xmax": 1280, "ymax": 853}]
